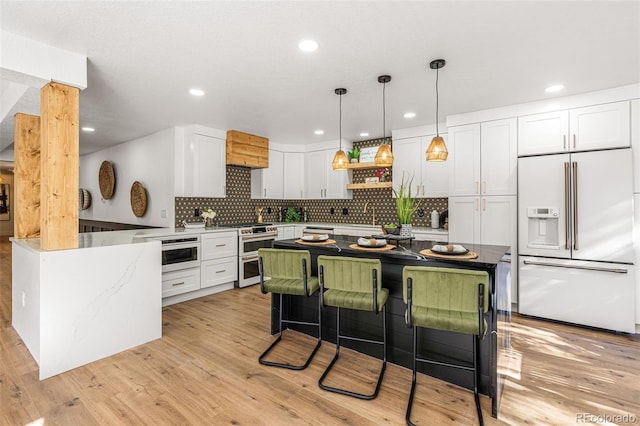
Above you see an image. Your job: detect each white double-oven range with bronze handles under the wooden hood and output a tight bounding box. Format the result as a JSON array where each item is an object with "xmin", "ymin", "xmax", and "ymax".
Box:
[{"xmin": 220, "ymin": 223, "xmax": 278, "ymax": 287}]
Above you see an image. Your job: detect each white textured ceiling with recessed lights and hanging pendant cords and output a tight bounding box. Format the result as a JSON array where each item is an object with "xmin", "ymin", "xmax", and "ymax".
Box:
[{"xmin": 0, "ymin": 0, "xmax": 640, "ymax": 153}]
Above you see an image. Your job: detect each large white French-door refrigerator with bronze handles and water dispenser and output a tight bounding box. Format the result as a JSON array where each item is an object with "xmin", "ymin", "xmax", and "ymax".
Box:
[{"xmin": 518, "ymin": 148, "xmax": 635, "ymax": 333}]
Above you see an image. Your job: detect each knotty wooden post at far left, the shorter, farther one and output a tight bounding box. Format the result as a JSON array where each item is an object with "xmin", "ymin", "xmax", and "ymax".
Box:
[{"xmin": 13, "ymin": 113, "xmax": 40, "ymax": 238}]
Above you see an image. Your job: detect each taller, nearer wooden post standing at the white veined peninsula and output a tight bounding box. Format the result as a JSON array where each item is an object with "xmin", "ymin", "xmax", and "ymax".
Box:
[{"xmin": 40, "ymin": 83, "xmax": 80, "ymax": 250}]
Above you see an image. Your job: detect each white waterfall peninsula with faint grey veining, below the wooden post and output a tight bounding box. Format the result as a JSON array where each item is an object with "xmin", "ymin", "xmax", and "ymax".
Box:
[{"xmin": 12, "ymin": 230, "xmax": 162, "ymax": 380}]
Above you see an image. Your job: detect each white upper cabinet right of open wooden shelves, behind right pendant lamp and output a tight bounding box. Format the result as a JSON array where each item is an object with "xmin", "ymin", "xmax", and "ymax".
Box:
[{"xmin": 393, "ymin": 134, "xmax": 451, "ymax": 197}]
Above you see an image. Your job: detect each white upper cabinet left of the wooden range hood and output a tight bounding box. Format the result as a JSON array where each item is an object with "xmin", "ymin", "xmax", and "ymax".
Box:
[{"xmin": 176, "ymin": 126, "xmax": 227, "ymax": 197}]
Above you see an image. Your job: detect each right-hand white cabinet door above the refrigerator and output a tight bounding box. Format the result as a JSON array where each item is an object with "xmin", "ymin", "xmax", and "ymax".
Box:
[{"xmin": 569, "ymin": 101, "xmax": 631, "ymax": 151}]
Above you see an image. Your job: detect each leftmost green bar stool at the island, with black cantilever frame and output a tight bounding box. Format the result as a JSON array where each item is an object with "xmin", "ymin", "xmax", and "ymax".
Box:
[{"xmin": 258, "ymin": 248, "xmax": 322, "ymax": 370}]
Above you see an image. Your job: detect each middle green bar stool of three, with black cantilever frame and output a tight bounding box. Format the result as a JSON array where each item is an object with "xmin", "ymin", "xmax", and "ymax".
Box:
[{"xmin": 318, "ymin": 256, "xmax": 389, "ymax": 399}]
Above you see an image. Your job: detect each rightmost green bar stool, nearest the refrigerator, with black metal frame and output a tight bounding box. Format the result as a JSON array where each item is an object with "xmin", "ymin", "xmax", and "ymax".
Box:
[{"xmin": 402, "ymin": 266, "xmax": 489, "ymax": 426}]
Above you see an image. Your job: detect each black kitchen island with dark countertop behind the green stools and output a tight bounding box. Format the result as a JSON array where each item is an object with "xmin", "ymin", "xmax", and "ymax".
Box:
[{"xmin": 271, "ymin": 235, "xmax": 511, "ymax": 417}]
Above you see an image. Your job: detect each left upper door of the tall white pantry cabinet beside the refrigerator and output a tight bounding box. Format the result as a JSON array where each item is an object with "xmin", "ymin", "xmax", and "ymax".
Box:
[{"xmin": 447, "ymin": 124, "xmax": 480, "ymax": 197}]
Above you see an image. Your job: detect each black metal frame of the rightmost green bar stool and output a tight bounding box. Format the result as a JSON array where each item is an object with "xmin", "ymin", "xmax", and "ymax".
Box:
[{"xmin": 406, "ymin": 277, "xmax": 485, "ymax": 426}]
